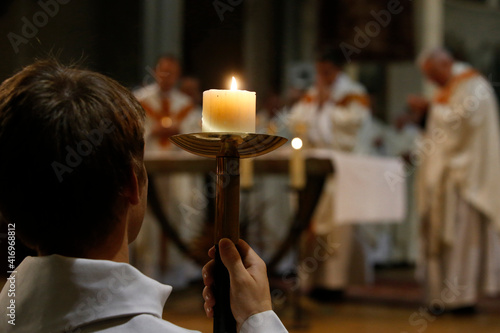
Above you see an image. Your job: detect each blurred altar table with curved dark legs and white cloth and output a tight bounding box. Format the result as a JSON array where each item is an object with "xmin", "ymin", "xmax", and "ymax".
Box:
[{"xmin": 145, "ymin": 147, "xmax": 406, "ymax": 274}]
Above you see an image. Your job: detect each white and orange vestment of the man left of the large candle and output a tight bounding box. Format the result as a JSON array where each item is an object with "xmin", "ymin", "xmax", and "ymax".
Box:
[{"xmin": 133, "ymin": 84, "xmax": 205, "ymax": 287}]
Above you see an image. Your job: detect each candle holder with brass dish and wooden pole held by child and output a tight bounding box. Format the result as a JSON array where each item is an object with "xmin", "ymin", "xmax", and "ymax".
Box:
[{"xmin": 170, "ymin": 132, "xmax": 287, "ymax": 333}]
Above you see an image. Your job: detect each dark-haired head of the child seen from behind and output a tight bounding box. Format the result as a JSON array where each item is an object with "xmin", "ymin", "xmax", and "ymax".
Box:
[{"xmin": 0, "ymin": 60, "xmax": 147, "ymax": 257}]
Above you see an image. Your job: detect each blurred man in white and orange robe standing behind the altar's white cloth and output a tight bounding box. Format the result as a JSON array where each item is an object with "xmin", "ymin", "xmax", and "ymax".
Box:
[{"xmin": 290, "ymin": 50, "xmax": 370, "ymax": 301}]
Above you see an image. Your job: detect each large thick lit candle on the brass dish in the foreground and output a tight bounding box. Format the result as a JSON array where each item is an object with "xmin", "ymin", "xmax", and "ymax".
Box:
[{"xmin": 202, "ymin": 77, "xmax": 256, "ymax": 133}]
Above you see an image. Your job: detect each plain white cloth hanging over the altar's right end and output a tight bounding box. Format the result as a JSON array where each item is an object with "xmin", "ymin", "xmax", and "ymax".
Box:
[{"xmin": 307, "ymin": 149, "xmax": 406, "ymax": 228}]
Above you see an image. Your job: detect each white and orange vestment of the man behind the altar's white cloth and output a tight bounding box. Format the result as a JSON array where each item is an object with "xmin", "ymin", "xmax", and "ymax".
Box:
[{"xmin": 290, "ymin": 73, "xmax": 370, "ymax": 289}]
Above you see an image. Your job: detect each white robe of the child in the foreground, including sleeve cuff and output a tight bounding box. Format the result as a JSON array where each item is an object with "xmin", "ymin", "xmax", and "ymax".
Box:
[{"xmin": 0, "ymin": 255, "xmax": 286, "ymax": 333}]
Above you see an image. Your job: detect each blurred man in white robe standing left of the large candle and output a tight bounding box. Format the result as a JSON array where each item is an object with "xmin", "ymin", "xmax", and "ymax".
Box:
[{"xmin": 134, "ymin": 55, "xmax": 205, "ymax": 287}]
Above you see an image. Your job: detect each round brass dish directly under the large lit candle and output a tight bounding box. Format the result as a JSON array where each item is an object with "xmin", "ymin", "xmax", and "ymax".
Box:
[{"xmin": 170, "ymin": 132, "xmax": 287, "ymax": 158}]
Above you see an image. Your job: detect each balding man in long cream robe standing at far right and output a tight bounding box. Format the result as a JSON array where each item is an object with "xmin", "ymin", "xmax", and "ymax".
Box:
[{"xmin": 417, "ymin": 49, "xmax": 500, "ymax": 313}]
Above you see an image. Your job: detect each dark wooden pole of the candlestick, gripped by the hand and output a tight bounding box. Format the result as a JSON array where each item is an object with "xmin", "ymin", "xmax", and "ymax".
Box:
[{"xmin": 214, "ymin": 140, "xmax": 240, "ymax": 333}]
